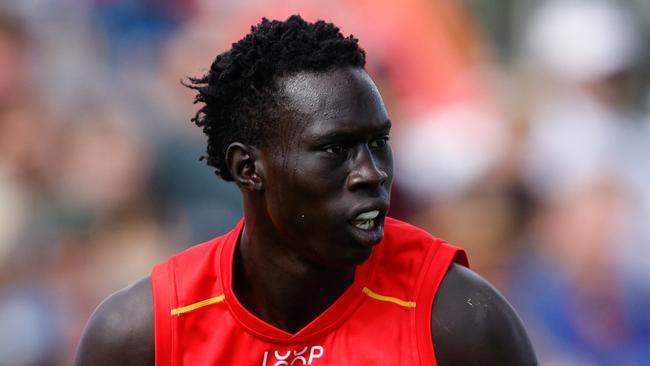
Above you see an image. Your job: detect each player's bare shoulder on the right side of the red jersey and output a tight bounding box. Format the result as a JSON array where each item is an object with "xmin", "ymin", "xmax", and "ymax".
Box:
[{"xmin": 431, "ymin": 264, "xmax": 537, "ymax": 366}]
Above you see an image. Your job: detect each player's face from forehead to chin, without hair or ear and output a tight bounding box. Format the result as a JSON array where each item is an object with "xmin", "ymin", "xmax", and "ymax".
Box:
[{"xmin": 262, "ymin": 68, "xmax": 393, "ymax": 267}]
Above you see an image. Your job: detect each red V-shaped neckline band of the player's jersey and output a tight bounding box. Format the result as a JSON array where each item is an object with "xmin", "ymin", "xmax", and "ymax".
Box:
[{"xmin": 218, "ymin": 219, "xmax": 383, "ymax": 343}]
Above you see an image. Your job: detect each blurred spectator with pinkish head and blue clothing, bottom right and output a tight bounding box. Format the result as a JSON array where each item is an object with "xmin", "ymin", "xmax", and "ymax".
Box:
[{"xmin": 510, "ymin": 177, "xmax": 650, "ymax": 365}]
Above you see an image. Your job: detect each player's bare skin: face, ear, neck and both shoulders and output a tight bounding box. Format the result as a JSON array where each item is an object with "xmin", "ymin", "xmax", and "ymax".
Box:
[{"xmin": 75, "ymin": 68, "xmax": 537, "ymax": 366}]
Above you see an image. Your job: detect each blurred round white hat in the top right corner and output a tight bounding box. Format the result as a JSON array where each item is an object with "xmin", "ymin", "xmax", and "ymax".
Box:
[{"xmin": 525, "ymin": 0, "xmax": 642, "ymax": 86}]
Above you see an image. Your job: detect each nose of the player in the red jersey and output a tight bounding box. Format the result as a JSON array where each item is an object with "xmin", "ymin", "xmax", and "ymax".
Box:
[{"xmin": 347, "ymin": 146, "xmax": 388, "ymax": 191}]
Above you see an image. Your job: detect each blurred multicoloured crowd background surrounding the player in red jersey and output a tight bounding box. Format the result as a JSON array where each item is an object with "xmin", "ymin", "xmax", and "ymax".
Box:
[{"xmin": 0, "ymin": 0, "xmax": 650, "ymax": 366}]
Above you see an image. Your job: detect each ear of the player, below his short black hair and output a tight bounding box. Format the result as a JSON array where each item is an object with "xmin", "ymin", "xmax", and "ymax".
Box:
[{"xmin": 226, "ymin": 142, "xmax": 264, "ymax": 191}]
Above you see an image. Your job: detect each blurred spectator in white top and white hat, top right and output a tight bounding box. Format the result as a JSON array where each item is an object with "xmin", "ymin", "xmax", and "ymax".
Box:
[{"xmin": 524, "ymin": 0, "xmax": 650, "ymax": 285}]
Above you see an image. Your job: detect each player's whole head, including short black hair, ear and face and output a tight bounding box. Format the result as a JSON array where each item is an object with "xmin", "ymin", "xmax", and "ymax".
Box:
[{"xmin": 185, "ymin": 16, "xmax": 393, "ymax": 266}]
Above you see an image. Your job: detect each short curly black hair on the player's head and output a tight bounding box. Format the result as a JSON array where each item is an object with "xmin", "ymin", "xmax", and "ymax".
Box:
[{"xmin": 186, "ymin": 15, "xmax": 366, "ymax": 181}]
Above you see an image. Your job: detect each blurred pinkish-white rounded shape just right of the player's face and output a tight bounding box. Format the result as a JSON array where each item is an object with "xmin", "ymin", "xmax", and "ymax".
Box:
[{"xmin": 395, "ymin": 102, "xmax": 508, "ymax": 203}]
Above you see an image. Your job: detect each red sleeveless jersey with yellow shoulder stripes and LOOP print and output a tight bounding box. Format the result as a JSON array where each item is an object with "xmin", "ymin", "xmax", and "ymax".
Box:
[{"xmin": 151, "ymin": 218, "xmax": 467, "ymax": 366}]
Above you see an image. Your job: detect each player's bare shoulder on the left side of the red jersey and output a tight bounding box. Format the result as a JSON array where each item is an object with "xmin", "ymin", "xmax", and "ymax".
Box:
[{"xmin": 74, "ymin": 277, "xmax": 154, "ymax": 366}]
